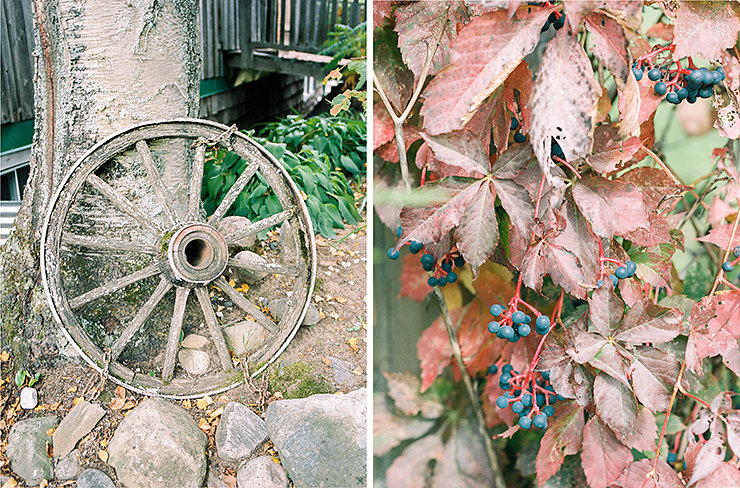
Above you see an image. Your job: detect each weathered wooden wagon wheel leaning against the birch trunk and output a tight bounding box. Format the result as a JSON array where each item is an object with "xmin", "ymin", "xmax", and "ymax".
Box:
[{"xmin": 41, "ymin": 119, "xmax": 316, "ymax": 398}]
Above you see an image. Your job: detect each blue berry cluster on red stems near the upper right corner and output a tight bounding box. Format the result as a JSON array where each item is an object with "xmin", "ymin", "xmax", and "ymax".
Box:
[{"xmin": 632, "ymin": 44, "xmax": 725, "ymax": 105}]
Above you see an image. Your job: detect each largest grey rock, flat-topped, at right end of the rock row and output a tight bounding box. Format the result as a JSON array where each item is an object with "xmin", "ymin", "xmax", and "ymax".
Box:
[{"xmin": 265, "ymin": 388, "xmax": 367, "ymax": 488}]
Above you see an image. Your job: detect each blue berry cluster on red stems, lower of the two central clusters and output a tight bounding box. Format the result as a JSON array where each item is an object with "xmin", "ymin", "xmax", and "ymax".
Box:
[{"xmin": 488, "ymin": 364, "xmax": 565, "ymax": 430}]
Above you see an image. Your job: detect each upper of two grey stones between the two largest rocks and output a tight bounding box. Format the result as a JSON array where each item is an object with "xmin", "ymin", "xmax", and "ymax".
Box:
[{"xmin": 216, "ymin": 402, "xmax": 267, "ymax": 464}]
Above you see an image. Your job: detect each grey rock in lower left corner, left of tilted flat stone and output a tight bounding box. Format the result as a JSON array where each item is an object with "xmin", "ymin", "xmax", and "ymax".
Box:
[{"xmin": 5, "ymin": 417, "xmax": 59, "ymax": 486}]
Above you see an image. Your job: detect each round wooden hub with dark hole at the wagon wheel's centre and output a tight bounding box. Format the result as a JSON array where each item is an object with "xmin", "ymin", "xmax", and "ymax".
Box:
[{"xmin": 167, "ymin": 223, "xmax": 229, "ymax": 284}]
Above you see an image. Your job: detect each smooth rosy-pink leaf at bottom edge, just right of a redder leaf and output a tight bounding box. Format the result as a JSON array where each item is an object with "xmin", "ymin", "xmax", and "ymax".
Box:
[{"xmin": 581, "ymin": 417, "xmax": 632, "ymax": 488}]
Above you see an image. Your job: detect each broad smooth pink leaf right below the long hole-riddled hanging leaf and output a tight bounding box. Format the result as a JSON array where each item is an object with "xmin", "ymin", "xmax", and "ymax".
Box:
[{"xmin": 573, "ymin": 175, "xmax": 649, "ymax": 237}]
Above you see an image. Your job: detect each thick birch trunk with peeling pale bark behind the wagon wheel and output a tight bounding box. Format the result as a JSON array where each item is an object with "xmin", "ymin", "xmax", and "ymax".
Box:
[{"xmin": 0, "ymin": 0, "xmax": 200, "ymax": 368}]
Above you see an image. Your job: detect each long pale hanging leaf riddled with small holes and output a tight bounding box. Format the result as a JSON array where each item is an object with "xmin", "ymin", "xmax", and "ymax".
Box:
[{"xmin": 529, "ymin": 29, "xmax": 601, "ymax": 182}]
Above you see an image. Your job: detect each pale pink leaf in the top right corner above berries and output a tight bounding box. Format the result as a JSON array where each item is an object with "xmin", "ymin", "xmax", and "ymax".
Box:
[{"xmin": 673, "ymin": 1, "xmax": 740, "ymax": 61}]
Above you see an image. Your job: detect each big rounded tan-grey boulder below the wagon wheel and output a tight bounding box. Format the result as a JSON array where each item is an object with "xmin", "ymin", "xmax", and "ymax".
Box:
[{"xmin": 108, "ymin": 398, "xmax": 206, "ymax": 488}]
